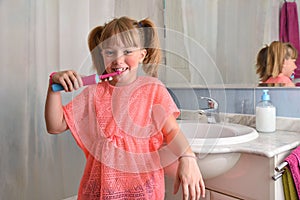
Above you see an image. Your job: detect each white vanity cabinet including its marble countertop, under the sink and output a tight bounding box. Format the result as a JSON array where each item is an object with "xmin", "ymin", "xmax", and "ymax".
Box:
[{"xmin": 165, "ymin": 121, "xmax": 300, "ymax": 200}]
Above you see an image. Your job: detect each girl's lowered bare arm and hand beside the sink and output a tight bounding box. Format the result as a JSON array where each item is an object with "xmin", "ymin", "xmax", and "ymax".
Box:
[{"xmin": 162, "ymin": 115, "xmax": 205, "ymax": 200}]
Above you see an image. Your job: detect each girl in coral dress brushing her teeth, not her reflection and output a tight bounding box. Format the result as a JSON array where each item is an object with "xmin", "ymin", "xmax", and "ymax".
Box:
[{"xmin": 45, "ymin": 17, "xmax": 205, "ymax": 200}]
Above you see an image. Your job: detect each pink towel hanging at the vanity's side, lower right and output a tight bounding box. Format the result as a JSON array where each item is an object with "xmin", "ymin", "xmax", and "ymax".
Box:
[{"xmin": 285, "ymin": 146, "xmax": 300, "ymax": 199}]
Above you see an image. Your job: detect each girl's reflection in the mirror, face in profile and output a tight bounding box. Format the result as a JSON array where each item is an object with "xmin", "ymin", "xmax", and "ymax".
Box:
[{"xmin": 263, "ymin": 41, "xmax": 297, "ymax": 87}]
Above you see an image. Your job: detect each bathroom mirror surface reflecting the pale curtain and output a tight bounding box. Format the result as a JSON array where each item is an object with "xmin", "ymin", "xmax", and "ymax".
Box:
[{"xmin": 165, "ymin": 0, "xmax": 290, "ymax": 87}]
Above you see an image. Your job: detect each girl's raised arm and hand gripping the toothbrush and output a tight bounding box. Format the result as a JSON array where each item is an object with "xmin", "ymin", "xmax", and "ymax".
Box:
[{"xmin": 45, "ymin": 70, "xmax": 82, "ymax": 134}]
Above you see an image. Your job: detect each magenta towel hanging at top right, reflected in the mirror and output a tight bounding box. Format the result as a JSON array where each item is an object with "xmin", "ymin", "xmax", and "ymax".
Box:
[{"xmin": 279, "ymin": 1, "xmax": 300, "ymax": 78}]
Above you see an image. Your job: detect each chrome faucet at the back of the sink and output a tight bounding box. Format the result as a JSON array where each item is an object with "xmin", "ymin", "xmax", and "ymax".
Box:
[{"xmin": 199, "ymin": 97, "xmax": 220, "ymax": 124}]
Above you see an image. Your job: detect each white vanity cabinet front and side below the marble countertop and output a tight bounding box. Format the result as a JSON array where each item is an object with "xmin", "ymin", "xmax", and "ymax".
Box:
[{"xmin": 205, "ymin": 151, "xmax": 290, "ymax": 200}]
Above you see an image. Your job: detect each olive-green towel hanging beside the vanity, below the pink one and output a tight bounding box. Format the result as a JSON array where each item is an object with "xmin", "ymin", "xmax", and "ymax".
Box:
[{"xmin": 282, "ymin": 166, "xmax": 298, "ymax": 200}]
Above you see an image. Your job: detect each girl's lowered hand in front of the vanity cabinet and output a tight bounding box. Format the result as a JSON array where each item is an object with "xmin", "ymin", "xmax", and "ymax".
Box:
[{"xmin": 174, "ymin": 157, "xmax": 205, "ymax": 200}]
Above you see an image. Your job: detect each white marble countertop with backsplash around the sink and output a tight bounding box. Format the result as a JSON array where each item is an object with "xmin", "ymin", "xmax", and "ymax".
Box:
[{"xmin": 188, "ymin": 113, "xmax": 300, "ymax": 157}]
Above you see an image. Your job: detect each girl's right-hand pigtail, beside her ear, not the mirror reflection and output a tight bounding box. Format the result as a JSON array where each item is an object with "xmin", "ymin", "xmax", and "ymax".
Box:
[{"xmin": 137, "ymin": 19, "xmax": 161, "ymax": 77}]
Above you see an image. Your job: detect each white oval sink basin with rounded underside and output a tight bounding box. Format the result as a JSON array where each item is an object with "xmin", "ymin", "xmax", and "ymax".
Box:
[{"xmin": 178, "ymin": 120, "xmax": 258, "ymax": 179}]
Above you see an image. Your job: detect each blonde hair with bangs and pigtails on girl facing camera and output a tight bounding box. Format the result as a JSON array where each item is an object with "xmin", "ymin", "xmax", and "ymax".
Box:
[{"xmin": 88, "ymin": 17, "xmax": 161, "ymax": 77}]
